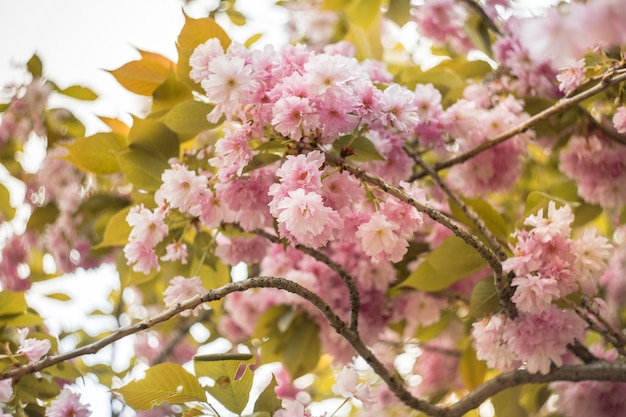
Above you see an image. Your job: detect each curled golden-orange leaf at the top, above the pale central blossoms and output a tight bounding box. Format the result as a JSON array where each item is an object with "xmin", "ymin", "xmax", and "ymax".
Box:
[{"xmin": 176, "ymin": 15, "xmax": 231, "ymax": 91}]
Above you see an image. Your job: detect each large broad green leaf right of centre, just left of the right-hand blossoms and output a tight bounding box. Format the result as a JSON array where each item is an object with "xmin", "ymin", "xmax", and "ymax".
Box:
[{"xmin": 400, "ymin": 236, "xmax": 487, "ymax": 291}]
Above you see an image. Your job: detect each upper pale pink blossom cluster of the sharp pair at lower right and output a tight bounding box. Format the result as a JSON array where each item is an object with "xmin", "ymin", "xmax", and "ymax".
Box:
[{"xmin": 502, "ymin": 201, "xmax": 612, "ymax": 314}]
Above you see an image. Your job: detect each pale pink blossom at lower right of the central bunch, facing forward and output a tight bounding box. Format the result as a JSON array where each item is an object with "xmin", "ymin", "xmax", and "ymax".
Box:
[{"xmin": 355, "ymin": 214, "xmax": 408, "ymax": 262}]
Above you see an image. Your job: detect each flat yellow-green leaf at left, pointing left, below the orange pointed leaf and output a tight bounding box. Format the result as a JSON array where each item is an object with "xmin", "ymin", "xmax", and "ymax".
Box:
[{"xmin": 63, "ymin": 132, "xmax": 126, "ymax": 175}]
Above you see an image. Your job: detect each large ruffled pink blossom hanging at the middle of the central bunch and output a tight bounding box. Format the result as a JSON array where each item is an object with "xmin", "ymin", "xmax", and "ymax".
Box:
[{"xmin": 276, "ymin": 189, "xmax": 342, "ymax": 248}]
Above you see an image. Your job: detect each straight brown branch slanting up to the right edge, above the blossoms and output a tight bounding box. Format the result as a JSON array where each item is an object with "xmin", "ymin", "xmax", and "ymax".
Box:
[{"xmin": 411, "ymin": 72, "xmax": 626, "ymax": 181}]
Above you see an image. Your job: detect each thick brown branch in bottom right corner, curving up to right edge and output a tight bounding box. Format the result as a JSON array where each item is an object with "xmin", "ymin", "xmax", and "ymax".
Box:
[{"xmin": 442, "ymin": 362, "xmax": 626, "ymax": 417}]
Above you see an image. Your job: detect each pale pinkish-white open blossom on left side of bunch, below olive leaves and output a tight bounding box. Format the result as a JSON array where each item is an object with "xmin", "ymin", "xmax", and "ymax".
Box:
[{"xmin": 154, "ymin": 164, "xmax": 208, "ymax": 217}]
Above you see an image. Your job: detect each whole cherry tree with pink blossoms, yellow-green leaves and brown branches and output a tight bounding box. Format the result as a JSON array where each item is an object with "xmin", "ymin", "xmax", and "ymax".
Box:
[{"xmin": 0, "ymin": 0, "xmax": 626, "ymax": 417}]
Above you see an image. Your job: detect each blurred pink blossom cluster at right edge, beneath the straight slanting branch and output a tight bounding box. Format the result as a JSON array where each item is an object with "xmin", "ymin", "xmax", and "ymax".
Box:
[{"xmin": 559, "ymin": 134, "xmax": 626, "ymax": 208}]
